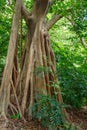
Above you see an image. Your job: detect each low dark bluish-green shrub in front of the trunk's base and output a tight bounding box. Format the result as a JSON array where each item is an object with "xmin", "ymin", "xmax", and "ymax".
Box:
[{"xmin": 32, "ymin": 95, "xmax": 65, "ymax": 130}]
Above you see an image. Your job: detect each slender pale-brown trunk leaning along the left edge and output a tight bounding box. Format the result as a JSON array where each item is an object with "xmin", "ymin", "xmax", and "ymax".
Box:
[{"xmin": 0, "ymin": 0, "xmax": 21, "ymax": 116}]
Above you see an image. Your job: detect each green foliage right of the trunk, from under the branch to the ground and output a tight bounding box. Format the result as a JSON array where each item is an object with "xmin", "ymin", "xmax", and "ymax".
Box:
[{"xmin": 50, "ymin": 20, "xmax": 87, "ymax": 108}]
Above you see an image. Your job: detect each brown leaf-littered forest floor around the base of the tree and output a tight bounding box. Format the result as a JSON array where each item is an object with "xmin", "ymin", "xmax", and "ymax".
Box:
[{"xmin": 0, "ymin": 109, "xmax": 87, "ymax": 130}]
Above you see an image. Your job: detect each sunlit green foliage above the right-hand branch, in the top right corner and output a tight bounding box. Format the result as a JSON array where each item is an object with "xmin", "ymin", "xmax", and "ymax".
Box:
[{"xmin": 47, "ymin": 0, "xmax": 87, "ymax": 40}]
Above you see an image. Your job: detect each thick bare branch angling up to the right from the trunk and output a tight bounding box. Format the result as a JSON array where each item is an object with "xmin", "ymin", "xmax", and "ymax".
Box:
[{"xmin": 47, "ymin": 14, "xmax": 63, "ymax": 30}]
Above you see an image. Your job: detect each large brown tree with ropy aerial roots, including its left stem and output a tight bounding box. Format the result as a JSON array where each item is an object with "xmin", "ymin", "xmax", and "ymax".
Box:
[{"xmin": 0, "ymin": 0, "xmax": 68, "ymax": 118}]
